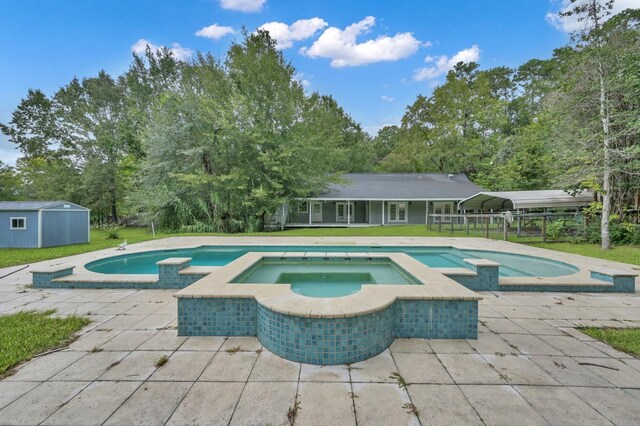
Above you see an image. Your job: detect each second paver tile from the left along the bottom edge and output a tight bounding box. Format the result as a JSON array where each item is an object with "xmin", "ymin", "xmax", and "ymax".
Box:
[{"xmin": 42, "ymin": 382, "xmax": 141, "ymax": 426}]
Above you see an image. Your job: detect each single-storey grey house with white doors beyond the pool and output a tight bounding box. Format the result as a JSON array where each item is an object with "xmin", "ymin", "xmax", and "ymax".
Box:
[{"xmin": 287, "ymin": 173, "xmax": 484, "ymax": 227}]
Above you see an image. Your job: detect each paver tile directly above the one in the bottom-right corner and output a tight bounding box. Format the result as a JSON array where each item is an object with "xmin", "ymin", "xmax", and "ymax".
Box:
[{"xmin": 528, "ymin": 355, "xmax": 613, "ymax": 387}]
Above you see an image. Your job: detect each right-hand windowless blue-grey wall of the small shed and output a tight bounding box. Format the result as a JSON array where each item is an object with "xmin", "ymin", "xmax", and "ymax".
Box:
[{"xmin": 42, "ymin": 209, "xmax": 89, "ymax": 247}]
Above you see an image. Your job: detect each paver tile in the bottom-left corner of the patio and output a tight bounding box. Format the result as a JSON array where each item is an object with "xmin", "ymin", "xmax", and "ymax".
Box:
[{"xmin": 0, "ymin": 382, "xmax": 88, "ymax": 425}]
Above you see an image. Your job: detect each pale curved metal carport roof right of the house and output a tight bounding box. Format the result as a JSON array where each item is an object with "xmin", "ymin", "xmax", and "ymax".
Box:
[{"xmin": 459, "ymin": 189, "xmax": 594, "ymax": 210}]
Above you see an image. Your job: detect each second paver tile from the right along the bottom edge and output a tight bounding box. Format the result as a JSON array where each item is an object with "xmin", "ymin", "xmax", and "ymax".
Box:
[{"xmin": 515, "ymin": 386, "xmax": 611, "ymax": 426}]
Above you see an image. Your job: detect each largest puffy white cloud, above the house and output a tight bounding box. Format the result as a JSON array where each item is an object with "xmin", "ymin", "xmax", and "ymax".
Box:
[{"xmin": 300, "ymin": 16, "xmax": 421, "ymax": 67}]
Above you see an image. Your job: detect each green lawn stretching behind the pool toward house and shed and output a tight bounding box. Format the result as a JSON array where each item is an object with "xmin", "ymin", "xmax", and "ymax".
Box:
[{"xmin": 0, "ymin": 225, "xmax": 640, "ymax": 268}]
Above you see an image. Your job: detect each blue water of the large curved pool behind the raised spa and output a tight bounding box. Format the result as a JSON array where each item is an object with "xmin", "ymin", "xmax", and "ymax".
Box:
[{"xmin": 85, "ymin": 246, "xmax": 578, "ymax": 277}]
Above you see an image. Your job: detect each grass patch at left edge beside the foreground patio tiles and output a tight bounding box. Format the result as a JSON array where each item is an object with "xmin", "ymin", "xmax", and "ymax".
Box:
[{"xmin": 0, "ymin": 310, "xmax": 90, "ymax": 377}]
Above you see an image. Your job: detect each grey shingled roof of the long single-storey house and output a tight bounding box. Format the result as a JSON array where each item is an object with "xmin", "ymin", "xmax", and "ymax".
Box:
[{"xmin": 311, "ymin": 173, "xmax": 483, "ymax": 200}]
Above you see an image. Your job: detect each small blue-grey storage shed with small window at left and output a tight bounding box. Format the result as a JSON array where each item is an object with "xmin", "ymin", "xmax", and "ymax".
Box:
[{"xmin": 0, "ymin": 201, "xmax": 90, "ymax": 248}]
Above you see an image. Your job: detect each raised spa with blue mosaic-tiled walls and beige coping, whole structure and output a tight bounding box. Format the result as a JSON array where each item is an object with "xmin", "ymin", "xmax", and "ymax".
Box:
[{"xmin": 175, "ymin": 253, "xmax": 481, "ymax": 365}]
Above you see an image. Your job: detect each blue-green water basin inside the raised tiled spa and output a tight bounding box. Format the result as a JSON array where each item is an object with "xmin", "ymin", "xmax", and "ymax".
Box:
[{"xmin": 231, "ymin": 257, "xmax": 420, "ymax": 297}]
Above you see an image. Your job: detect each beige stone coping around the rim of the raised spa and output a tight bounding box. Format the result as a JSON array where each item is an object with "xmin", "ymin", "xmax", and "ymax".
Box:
[{"xmin": 174, "ymin": 251, "xmax": 482, "ymax": 318}]
